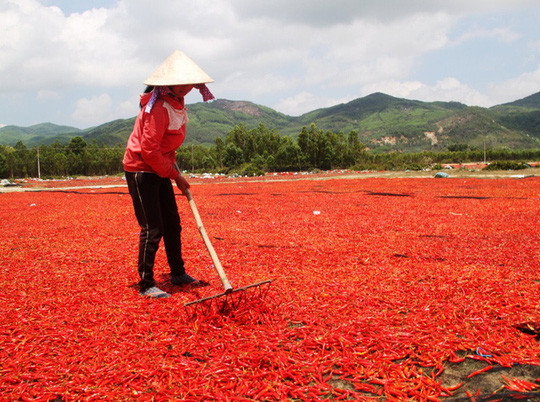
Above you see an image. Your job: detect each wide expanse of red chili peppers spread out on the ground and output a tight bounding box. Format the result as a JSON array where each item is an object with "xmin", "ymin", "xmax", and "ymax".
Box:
[{"xmin": 0, "ymin": 177, "xmax": 540, "ymax": 401}]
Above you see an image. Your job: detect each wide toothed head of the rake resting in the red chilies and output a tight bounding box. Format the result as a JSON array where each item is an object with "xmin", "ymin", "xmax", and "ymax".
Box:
[{"xmin": 184, "ymin": 279, "xmax": 273, "ymax": 319}]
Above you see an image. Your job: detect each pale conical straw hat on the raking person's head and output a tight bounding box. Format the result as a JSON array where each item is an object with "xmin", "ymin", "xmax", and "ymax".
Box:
[{"xmin": 144, "ymin": 50, "xmax": 214, "ymax": 86}]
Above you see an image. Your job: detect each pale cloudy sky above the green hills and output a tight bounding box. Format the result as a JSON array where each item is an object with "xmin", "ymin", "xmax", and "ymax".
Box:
[{"xmin": 0, "ymin": 0, "xmax": 540, "ymax": 129}]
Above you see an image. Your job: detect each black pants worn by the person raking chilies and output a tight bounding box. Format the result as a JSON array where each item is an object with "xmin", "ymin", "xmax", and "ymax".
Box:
[{"xmin": 126, "ymin": 172, "xmax": 185, "ymax": 291}]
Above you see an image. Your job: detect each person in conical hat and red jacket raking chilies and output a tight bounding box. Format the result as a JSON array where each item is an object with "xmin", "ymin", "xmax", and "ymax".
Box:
[{"xmin": 123, "ymin": 50, "xmax": 214, "ymax": 298}]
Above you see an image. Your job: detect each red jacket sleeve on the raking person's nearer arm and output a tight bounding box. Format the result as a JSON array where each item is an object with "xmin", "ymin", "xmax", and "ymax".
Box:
[{"xmin": 141, "ymin": 104, "xmax": 178, "ymax": 179}]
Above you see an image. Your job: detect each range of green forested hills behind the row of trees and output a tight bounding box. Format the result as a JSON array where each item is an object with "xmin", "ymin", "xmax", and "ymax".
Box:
[{"xmin": 0, "ymin": 92, "xmax": 540, "ymax": 151}]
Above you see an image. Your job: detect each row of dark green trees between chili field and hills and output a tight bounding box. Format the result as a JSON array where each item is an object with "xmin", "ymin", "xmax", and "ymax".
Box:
[{"xmin": 0, "ymin": 124, "xmax": 540, "ymax": 178}]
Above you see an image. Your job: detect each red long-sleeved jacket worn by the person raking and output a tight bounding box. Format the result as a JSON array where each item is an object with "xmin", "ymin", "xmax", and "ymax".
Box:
[{"xmin": 123, "ymin": 93, "xmax": 187, "ymax": 179}]
